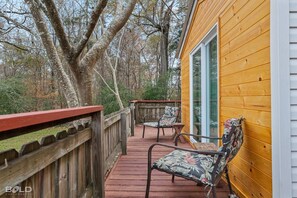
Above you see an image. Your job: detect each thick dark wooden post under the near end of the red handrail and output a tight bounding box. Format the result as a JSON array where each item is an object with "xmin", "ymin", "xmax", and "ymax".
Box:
[{"xmin": 91, "ymin": 111, "xmax": 105, "ymax": 198}]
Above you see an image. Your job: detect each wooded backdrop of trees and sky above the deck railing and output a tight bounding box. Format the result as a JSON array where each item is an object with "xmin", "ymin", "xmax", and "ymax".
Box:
[{"xmin": 0, "ymin": 0, "xmax": 187, "ymax": 114}]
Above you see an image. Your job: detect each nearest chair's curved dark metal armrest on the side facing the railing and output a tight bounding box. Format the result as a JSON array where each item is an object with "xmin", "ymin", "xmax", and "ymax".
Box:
[{"xmin": 148, "ymin": 143, "xmax": 225, "ymax": 166}]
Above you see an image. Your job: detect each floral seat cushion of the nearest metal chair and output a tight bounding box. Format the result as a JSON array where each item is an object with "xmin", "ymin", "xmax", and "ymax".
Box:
[{"xmin": 153, "ymin": 150, "xmax": 213, "ymax": 184}]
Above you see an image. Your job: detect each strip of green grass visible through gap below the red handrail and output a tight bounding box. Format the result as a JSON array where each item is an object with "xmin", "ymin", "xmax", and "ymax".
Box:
[{"xmin": 0, "ymin": 127, "xmax": 65, "ymax": 152}]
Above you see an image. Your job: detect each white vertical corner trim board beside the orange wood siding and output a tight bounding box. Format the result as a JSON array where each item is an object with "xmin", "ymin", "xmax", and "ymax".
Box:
[{"xmin": 270, "ymin": 0, "xmax": 292, "ymax": 198}]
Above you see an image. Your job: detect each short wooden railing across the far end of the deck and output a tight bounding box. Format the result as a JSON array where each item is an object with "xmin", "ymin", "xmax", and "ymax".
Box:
[{"xmin": 130, "ymin": 100, "xmax": 181, "ymax": 124}]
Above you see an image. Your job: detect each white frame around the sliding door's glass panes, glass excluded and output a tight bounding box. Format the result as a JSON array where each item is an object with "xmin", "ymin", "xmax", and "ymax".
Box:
[{"xmin": 189, "ymin": 24, "xmax": 219, "ymax": 142}]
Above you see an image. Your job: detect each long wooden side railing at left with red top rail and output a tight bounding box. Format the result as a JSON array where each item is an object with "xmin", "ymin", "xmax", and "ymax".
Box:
[{"xmin": 0, "ymin": 106, "xmax": 131, "ymax": 197}]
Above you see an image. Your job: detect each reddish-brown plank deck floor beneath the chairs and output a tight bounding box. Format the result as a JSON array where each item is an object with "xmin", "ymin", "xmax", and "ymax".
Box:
[{"xmin": 105, "ymin": 126, "xmax": 229, "ymax": 198}]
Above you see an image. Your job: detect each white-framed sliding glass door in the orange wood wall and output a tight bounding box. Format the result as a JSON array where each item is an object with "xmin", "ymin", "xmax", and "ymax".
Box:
[{"xmin": 190, "ymin": 29, "xmax": 218, "ymax": 143}]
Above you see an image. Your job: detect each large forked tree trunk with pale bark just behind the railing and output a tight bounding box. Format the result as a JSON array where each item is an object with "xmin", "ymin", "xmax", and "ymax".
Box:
[{"xmin": 25, "ymin": 0, "xmax": 136, "ymax": 107}]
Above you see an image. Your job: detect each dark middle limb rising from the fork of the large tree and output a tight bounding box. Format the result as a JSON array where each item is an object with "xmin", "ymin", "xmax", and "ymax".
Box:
[{"xmin": 73, "ymin": 0, "xmax": 108, "ymax": 58}]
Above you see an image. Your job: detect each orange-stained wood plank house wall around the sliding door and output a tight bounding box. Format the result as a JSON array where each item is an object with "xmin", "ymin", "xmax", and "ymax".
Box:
[{"xmin": 180, "ymin": 0, "xmax": 272, "ymax": 197}]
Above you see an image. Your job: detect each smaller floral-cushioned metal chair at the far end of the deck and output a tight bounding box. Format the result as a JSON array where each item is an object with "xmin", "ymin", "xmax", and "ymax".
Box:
[{"xmin": 142, "ymin": 106, "xmax": 179, "ymax": 142}]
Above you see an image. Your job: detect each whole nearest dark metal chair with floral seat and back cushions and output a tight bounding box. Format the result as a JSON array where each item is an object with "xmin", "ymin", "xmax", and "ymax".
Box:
[{"xmin": 145, "ymin": 118, "xmax": 243, "ymax": 198}]
